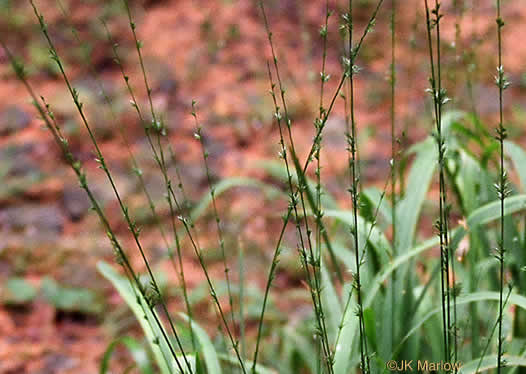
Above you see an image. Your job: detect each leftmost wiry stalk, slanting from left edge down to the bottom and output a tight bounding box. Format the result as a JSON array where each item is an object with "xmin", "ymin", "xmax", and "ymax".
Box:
[{"xmin": 0, "ymin": 43, "xmax": 186, "ymax": 373}]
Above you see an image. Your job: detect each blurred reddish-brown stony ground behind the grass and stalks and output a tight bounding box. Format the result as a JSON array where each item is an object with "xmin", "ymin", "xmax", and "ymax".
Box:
[{"xmin": 0, "ymin": 0, "xmax": 526, "ymax": 374}]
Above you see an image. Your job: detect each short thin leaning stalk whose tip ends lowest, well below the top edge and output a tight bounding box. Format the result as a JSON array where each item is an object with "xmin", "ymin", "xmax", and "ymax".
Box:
[{"xmin": 192, "ymin": 100, "xmax": 235, "ymax": 324}]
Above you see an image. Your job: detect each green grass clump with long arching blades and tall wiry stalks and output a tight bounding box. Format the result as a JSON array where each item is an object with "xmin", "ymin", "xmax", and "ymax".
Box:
[{"xmin": 2, "ymin": 0, "xmax": 526, "ymax": 374}]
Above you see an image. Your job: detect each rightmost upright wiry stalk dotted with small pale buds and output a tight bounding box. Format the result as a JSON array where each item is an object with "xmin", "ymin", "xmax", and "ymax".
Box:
[{"xmin": 495, "ymin": 0, "xmax": 510, "ymax": 374}]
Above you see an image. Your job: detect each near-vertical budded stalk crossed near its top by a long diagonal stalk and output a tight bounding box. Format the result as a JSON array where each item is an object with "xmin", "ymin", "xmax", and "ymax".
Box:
[{"xmin": 344, "ymin": 0, "xmax": 371, "ymax": 373}]
